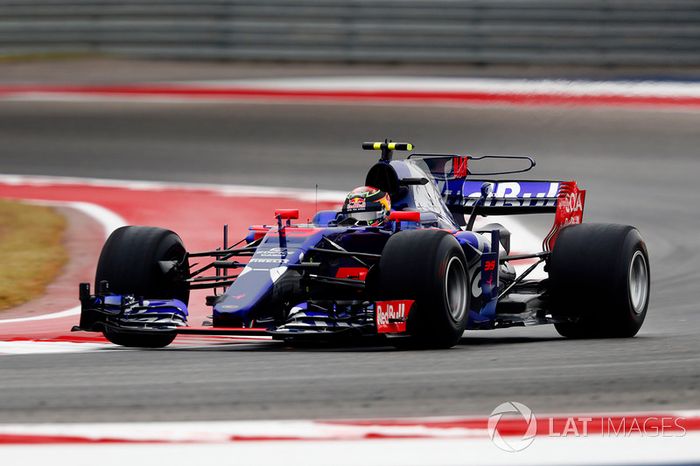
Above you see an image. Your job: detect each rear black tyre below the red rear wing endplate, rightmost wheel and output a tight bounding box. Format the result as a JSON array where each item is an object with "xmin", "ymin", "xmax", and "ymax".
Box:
[{"xmin": 548, "ymin": 223, "xmax": 651, "ymax": 338}]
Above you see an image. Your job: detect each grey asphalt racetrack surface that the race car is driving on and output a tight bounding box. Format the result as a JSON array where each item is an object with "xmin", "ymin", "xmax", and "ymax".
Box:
[{"xmin": 0, "ymin": 98, "xmax": 700, "ymax": 422}]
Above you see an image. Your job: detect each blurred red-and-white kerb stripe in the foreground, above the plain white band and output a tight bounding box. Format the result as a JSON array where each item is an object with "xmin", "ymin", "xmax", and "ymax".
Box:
[{"xmin": 0, "ymin": 410, "xmax": 700, "ymax": 440}]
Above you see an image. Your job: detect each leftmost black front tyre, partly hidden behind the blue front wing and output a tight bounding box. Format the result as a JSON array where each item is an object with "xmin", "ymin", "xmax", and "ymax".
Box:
[{"xmin": 95, "ymin": 226, "xmax": 190, "ymax": 348}]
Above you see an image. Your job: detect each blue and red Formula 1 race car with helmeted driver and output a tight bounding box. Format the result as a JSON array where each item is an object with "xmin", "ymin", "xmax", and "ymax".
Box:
[{"xmin": 74, "ymin": 141, "xmax": 650, "ymax": 348}]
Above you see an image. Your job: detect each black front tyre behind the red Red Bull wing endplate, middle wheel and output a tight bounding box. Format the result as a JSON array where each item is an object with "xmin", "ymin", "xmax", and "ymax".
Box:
[{"xmin": 379, "ymin": 230, "xmax": 469, "ymax": 349}]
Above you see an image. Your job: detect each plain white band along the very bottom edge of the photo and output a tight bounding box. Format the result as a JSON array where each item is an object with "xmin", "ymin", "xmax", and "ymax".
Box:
[{"xmin": 0, "ymin": 433, "xmax": 700, "ymax": 466}]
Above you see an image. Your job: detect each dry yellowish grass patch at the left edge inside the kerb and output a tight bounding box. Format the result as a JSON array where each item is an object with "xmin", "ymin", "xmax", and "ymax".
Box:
[{"xmin": 0, "ymin": 199, "xmax": 68, "ymax": 310}]
